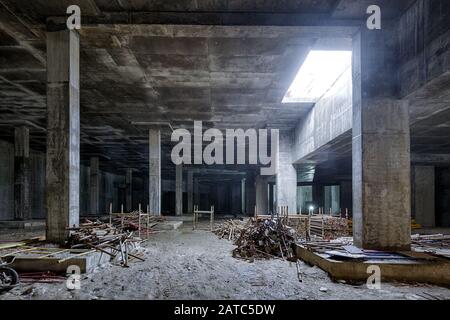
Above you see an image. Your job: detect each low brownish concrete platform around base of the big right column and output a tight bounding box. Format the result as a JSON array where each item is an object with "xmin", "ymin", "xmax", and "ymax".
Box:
[{"xmin": 296, "ymin": 245, "xmax": 450, "ymax": 286}]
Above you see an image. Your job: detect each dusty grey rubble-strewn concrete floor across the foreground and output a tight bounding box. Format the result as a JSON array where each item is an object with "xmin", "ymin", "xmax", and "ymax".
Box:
[{"xmin": 0, "ymin": 225, "xmax": 450, "ymax": 300}]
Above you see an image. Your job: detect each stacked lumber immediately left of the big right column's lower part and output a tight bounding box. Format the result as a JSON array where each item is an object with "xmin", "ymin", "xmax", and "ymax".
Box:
[{"xmin": 309, "ymin": 215, "xmax": 348, "ymax": 239}]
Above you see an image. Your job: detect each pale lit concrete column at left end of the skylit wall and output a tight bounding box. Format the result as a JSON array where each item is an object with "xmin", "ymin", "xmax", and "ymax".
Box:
[{"xmin": 274, "ymin": 132, "xmax": 297, "ymax": 214}]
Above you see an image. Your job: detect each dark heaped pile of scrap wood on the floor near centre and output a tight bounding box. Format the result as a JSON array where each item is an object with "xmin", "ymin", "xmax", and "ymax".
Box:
[{"xmin": 233, "ymin": 219, "xmax": 297, "ymax": 261}]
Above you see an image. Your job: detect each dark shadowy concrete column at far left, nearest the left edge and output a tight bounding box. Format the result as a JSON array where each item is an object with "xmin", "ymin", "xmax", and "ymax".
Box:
[{"xmin": 14, "ymin": 127, "xmax": 31, "ymax": 220}]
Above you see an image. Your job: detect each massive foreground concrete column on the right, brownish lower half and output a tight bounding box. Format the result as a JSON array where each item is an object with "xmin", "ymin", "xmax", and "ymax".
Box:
[{"xmin": 352, "ymin": 27, "xmax": 411, "ymax": 251}]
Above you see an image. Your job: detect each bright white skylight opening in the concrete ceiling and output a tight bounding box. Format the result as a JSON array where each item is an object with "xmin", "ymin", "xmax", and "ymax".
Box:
[{"xmin": 282, "ymin": 50, "xmax": 352, "ymax": 103}]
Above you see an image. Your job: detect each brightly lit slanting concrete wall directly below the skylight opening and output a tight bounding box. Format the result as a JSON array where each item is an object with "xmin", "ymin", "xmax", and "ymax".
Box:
[{"xmin": 293, "ymin": 68, "xmax": 352, "ymax": 162}]
